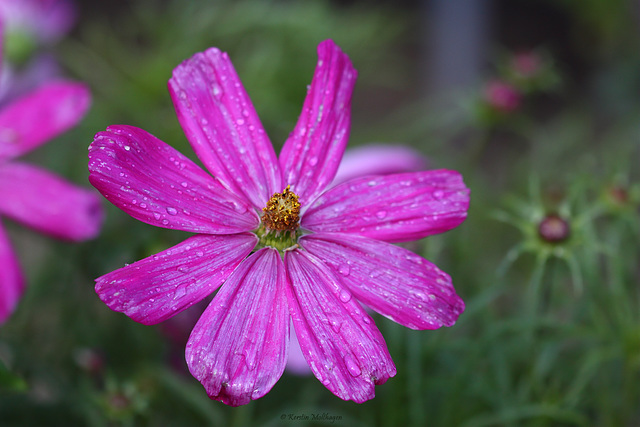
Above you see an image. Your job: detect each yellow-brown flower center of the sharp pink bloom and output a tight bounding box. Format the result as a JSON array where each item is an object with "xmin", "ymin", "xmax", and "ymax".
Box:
[{"xmin": 256, "ymin": 185, "xmax": 300, "ymax": 253}]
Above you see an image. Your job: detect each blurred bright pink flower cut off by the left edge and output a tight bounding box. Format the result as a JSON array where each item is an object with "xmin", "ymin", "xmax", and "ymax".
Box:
[{"xmin": 0, "ymin": 78, "xmax": 103, "ymax": 323}]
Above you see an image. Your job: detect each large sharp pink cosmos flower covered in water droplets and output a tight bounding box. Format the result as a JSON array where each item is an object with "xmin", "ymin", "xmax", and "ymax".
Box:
[{"xmin": 89, "ymin": 40, "xmax": 469, "ymax": 406}]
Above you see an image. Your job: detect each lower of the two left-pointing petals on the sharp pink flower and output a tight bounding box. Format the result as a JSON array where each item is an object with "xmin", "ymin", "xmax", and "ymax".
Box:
[{"xmin": 96, "ymin": 233, "xmax": 257, "ymax": 325}]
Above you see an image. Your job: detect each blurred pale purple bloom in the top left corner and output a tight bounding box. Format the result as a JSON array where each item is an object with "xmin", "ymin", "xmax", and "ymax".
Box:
[{"xmin": 0, "ymin": 0, "xmax": 76, "ymax": 103}]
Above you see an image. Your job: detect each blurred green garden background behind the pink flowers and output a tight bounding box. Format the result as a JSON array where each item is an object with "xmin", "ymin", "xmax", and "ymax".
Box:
[{"xmin": 0, "ymin": 0, "xmax": 640, "ymax": 427}]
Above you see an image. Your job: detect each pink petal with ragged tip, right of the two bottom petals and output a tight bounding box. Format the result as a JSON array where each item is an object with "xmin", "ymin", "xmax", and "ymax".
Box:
[{"xmin": 285, "ymin": 249, "xmax": 396, "ymax": 403}]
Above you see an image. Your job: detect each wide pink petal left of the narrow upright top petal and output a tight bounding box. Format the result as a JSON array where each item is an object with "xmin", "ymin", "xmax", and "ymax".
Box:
[{"xmin": 169, "ymin": 48, "xmax": 282, "ymax": 209}]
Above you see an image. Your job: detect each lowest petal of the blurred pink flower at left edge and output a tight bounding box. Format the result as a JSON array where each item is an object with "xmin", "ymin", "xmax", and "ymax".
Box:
[{"xmin": 0, "ymin": 224, "xmax": 24, "ymax": 324}]
